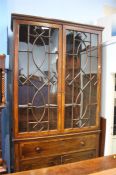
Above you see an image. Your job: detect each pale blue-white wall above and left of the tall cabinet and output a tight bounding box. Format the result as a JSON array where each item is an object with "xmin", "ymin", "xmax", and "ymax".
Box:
[{"xmin": 0, "ymin": 0, "xmax": 116, "ymax": 54}]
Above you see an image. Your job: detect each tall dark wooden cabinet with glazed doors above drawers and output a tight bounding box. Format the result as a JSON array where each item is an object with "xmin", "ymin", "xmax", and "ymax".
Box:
[{"xmin": 12, "ymin": 14, "xmax": 103, "ymax": 171}]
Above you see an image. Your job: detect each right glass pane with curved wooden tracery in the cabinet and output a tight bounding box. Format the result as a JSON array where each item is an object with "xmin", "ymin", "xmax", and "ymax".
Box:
[{"xmin": 65, "ymin": 30, "xmax": 98, "ymax": 128}]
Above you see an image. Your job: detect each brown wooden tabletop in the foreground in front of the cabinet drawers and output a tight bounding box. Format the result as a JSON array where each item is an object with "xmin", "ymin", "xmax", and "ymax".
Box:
[{"xmin": 9, "ymin": 155, "xmax": 116, "ymax": 175}]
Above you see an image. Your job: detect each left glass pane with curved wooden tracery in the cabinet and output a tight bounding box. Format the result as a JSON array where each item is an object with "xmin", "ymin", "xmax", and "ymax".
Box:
[{"xmin": 19, "ymin": 25, "xmax": 58, "ymax": 132}]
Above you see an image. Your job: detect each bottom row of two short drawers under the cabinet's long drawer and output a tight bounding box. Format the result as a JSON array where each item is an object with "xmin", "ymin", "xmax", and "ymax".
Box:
[{"xmin": 20, "ymin": 150, "xmax": 96, "ymax": 170}]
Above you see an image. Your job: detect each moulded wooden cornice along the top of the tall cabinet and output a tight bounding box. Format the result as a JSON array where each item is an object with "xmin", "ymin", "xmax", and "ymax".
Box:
[{"xmin": 11, "ymin": 13, "xmax": 104, "ymax": 31}]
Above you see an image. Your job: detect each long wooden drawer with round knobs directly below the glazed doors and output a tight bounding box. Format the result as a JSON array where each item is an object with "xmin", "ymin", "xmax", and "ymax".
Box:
[{"xmin": 20, "ymin": 134, "xmax": 98, "ymax": 159}]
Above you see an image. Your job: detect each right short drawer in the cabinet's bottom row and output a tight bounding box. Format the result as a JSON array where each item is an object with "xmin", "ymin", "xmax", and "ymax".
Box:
[{"xmin": 61, "ymin": 150, "xmax": 98, "ymax": 164}]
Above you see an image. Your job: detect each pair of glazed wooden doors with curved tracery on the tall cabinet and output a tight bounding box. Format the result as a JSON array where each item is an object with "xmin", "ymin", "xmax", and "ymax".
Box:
[{"xmin": 13, "ymin": 20, "xmax": 99, "ymax": 137}]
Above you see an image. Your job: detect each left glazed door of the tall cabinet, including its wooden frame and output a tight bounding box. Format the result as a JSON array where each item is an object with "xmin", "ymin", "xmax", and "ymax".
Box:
[{"xmin": 13, "ymin": 21, "xmax": 62, "ymax": 137}]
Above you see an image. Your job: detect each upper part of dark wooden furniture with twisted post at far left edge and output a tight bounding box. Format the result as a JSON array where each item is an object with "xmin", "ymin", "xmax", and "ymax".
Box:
[{"xmin": 0, "ymin": 55, "xmax": 5, "ymax": 109}]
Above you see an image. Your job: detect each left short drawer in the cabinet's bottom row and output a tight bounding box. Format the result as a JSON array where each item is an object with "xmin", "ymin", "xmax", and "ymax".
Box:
[{"xmin": 20, "ymin": 156, "xmax": 61, "ymax": 171}]
